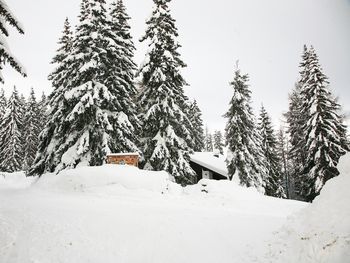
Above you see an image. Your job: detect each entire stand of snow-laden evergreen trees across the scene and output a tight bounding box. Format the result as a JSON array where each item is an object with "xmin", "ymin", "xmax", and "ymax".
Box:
[{"xmin": 0, "ymin": 0, "xmax": 350, "ymax": 201}]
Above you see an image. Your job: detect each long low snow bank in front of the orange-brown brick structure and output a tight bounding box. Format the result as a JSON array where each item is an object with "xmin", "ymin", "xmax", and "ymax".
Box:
[{"xmin": 34, "ymin": 164, "xmax": 172, "ymax": 193}]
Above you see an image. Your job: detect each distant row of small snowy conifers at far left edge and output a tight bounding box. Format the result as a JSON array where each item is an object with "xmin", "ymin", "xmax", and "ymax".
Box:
[{"xmin": 0, "ymin": 87, "xmax": 47, "ymax": 172}]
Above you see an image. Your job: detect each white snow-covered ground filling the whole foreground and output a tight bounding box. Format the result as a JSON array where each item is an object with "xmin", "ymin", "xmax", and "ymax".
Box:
[{"xmin": 0, "ymin": 156, "xmax": 350, "ymax": 263}]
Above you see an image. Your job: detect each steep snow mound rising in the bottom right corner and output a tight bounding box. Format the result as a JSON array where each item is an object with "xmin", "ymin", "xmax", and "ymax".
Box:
[{"xmin": 263, "ymin": 154, "xmax": 350, "ymax": 263}]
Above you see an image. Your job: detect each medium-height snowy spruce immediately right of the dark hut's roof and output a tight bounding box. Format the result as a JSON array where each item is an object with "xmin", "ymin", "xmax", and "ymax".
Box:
[{"xmin": 224, "ymin": 69, "xmax": 267, "ymax": 192}]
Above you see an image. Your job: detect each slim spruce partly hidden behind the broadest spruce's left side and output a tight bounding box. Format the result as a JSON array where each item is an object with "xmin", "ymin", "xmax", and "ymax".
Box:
[{"xmin": 28, "ymin": 18, "xmax": 74, "ymax": 175}]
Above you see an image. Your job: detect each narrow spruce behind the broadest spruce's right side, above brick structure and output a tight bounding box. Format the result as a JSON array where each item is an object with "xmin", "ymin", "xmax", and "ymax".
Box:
[{"xmin": 105, "ymin": 0, "xmax": 141, "ymax": 153}]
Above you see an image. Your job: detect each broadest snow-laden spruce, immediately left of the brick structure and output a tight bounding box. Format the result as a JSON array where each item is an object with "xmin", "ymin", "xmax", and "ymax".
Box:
[{"xmin": 30, "ymin": 0, "xmax": 137, "ymax": 177}]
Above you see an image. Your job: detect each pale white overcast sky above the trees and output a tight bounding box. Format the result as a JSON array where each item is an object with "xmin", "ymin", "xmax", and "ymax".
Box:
[{"xmin": 3, "ymin": 0, "xmax": 350, "ymax": 131}]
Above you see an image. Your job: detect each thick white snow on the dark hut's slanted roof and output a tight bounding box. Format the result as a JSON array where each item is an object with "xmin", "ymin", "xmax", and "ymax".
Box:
[{"xmin": 190, "ymin": 152, "xmax": 228, "ymax": 177}]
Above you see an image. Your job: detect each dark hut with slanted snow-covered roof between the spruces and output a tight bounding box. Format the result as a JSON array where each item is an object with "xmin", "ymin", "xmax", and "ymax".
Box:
[{"xmin": 190, "ymin": 152, "xmax": 228, "ymax": 184}]
